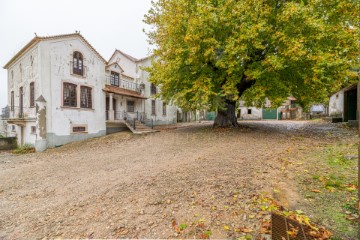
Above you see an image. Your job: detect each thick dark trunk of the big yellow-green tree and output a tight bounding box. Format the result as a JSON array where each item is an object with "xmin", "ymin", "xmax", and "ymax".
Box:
[{"xmin": 213, "ymin": 100, "xmax": 239, "ymax": 127}]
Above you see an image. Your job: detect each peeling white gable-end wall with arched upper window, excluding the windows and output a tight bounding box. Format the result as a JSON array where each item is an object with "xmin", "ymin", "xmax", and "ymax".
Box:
[{"xmin": 41, "ymin": 38, "xmax": 106, "ymax": 147}]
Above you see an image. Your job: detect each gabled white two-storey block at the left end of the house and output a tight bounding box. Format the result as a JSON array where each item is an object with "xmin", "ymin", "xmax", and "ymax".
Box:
[{"xmin": 4, "ymin": 33, "xmax": 107, "ymax": 150}]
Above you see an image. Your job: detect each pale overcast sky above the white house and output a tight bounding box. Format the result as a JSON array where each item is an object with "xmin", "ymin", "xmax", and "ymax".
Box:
[{"xmin": 0, "ymin": 0, "xmax": 151, "ymax": 109}]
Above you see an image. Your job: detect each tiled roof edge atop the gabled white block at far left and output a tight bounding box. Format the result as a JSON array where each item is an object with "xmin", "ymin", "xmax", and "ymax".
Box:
[{"xmin": 4, "ymin": 33, "xmax": 107, "ymax": 69}]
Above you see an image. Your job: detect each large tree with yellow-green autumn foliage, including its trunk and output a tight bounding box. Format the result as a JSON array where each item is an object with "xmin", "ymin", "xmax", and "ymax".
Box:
[{"xmin": 145, "ymin": 0, "xmax": 359, "ymax": 126}]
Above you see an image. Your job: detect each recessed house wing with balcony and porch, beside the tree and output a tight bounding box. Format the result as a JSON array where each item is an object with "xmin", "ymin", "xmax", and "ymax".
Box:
[{"xmin": 104, "ymin": 50, "xmax": 177, "ymax": 132}]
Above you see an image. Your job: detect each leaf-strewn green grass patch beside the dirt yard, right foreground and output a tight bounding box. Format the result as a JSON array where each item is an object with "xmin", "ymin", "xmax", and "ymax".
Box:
[{"xmin": 300, "ymin": 142, "xmax": 359, "ymax": 239}]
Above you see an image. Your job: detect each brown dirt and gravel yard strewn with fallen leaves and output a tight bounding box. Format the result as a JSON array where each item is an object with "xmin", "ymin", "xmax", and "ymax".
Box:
[{"xmin": 0, "ymin": 121, "xmax": 357, "ymax": 239}]
